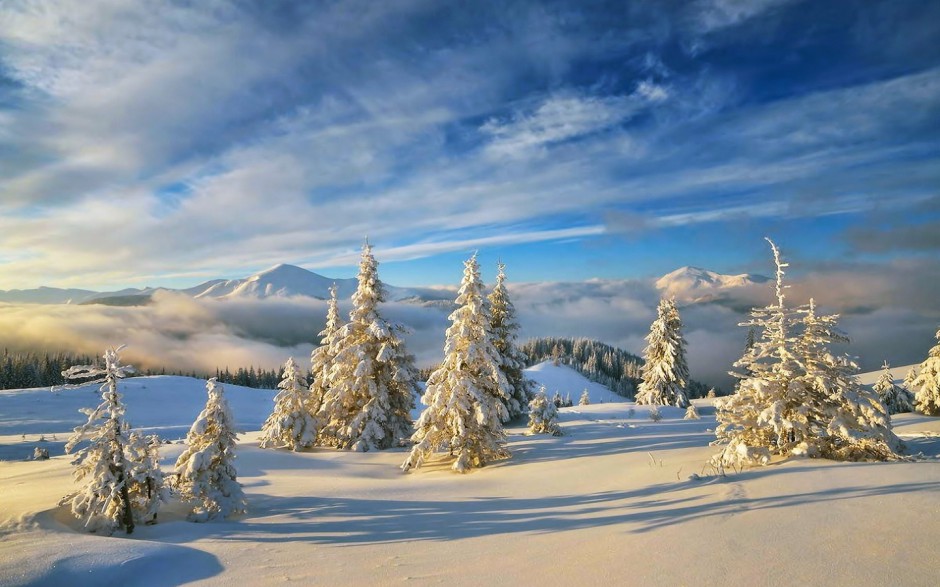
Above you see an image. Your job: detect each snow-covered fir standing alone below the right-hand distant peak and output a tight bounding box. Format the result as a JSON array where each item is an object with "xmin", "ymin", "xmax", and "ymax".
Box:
[{"xmin": 636, "ymin": 299, "xmax": 689, "ymax": 408}]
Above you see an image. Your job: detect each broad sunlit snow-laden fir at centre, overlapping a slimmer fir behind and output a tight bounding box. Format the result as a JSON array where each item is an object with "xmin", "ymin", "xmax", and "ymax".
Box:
[{"xmin": 402, "ymin": 255, "xmax": 510, "ymax": 473}]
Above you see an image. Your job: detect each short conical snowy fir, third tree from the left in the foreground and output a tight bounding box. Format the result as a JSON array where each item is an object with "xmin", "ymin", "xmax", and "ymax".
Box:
[{"xmin": 175, "ymin": 377, "xmax": 247, "ymax": 522}]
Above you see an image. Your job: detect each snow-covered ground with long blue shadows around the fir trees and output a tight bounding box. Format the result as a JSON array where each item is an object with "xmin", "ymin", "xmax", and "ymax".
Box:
[{"xmin": 0, "ymin": 364, "xmax": 940, "ymax": 586}]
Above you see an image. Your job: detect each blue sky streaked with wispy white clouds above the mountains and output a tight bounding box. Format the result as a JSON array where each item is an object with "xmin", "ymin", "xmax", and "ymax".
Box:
[{"xmin": 0, "ymin": 0, "xmax": 940, "ymax": 289}]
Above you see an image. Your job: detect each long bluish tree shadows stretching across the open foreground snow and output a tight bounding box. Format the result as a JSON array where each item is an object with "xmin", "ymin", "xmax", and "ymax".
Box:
[{"xmin": 158, "ymin": 464, "xmax": 940, "ymax": 546}]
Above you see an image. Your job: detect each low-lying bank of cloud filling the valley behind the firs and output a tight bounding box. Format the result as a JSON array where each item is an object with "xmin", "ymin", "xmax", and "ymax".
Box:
[{"xmin": 0, "ymin": 268, "xmax": 940, "ymax": 386}]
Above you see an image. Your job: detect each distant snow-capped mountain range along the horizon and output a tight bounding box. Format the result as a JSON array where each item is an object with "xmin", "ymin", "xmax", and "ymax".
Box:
[{"xmin": 0, "ymin": 264, "xmax": 769, "ymax": 306}]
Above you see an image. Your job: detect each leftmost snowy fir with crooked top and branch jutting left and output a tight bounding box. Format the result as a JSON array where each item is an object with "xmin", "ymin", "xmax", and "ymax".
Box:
[{"xmin": 62, "ymin": 347, "xmax": 135, "ymax": 534}]
